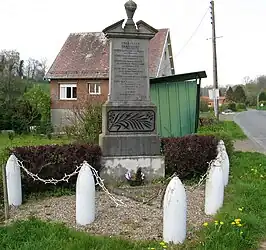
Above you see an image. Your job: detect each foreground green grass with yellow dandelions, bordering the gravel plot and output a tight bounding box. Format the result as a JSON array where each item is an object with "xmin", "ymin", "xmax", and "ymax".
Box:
[{"xmin": 0, "ymin": 152, "xmax": 266, "ymax": 250}]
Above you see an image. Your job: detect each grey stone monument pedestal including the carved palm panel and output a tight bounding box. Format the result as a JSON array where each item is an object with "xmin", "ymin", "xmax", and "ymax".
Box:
[{"xmin": 99, "ymin": 101, "xmax": 160, "ymax": 156}]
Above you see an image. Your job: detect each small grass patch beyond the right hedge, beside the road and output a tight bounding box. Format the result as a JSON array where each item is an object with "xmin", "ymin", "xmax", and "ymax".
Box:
[{"xmin": 198, "ymin": 121, "xmax": 247, "ymax": 140}]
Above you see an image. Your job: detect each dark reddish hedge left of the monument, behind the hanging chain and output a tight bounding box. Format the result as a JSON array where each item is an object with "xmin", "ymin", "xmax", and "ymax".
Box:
[{"xmin": 10, "ymin": 144, "xmax": 101, "ymax": 195}]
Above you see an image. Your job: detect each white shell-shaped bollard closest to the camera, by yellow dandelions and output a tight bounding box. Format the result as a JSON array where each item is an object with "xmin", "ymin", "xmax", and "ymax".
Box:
[{"xmin": 163, "ymin": 177, "xmax": 187, "ymax": 244}]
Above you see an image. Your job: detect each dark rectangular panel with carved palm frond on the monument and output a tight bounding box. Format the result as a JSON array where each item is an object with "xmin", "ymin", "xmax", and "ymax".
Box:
[{"xmin": 107, "ymin": 110, "xmax": 155, "ymax": 132}]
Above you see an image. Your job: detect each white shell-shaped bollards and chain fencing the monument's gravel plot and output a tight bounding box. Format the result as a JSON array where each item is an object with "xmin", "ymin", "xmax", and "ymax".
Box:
[{"xmin": 3, "ymin": 141, "xmax": 229, "ymax": 244}]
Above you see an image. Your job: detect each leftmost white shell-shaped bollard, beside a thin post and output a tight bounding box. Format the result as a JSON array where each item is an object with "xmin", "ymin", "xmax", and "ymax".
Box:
[{"xmin": 6, "ymin": 154, "xmax": 22, "ymax": 206}]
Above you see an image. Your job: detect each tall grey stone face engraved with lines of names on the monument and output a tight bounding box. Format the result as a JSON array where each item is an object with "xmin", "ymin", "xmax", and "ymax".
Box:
[{"xmin": 111, "ymin": 38, "xmax": 149, "ymax": 101}]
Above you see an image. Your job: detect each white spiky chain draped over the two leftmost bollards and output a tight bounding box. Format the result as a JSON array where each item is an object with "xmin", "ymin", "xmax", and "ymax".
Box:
[{"xmin": 17, "ymin": 156, "xmax": 126, "ymax": 207}]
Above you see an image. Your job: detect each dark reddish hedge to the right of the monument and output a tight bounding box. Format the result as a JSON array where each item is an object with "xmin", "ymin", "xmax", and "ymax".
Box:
[{"xmin": 161, "ymin": 135, "xmax": 218, "ymax": 180}]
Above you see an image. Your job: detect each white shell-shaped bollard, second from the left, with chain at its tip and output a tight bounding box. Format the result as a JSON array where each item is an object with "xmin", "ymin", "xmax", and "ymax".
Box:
[{"xmin": 76, "ymin": 162, "xmax": 95, "ymax": 226}]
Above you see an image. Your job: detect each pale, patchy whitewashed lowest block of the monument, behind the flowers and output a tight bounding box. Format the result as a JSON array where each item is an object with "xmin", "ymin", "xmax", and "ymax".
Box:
[{"xmin": 100, "ymin": 155, "xmax": 165, "ymax": 184}]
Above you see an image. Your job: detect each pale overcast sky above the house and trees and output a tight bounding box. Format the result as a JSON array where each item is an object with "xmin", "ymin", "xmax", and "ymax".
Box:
[{"xmin": 0, "ymin": 0, "xmax": 266, "ymax": 85}]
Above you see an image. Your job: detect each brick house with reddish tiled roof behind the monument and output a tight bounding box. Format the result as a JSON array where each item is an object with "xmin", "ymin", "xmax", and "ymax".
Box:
[{"xmin": 45, "ymin": 29, "xmax": 175, "ymax": 128}]
